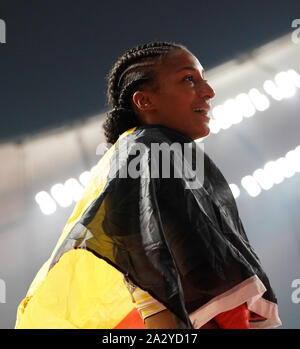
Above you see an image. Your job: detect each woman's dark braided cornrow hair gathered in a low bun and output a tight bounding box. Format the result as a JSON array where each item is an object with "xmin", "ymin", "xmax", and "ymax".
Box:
[{"xmin": 103, "ymin": 42, "xmax": 186, "ymax": 144}]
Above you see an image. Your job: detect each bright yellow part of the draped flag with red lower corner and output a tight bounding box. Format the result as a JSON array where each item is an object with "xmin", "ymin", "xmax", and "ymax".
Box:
[{"xmin": 15, "ymin": 126, "xmax": 145, "ymax": 329}]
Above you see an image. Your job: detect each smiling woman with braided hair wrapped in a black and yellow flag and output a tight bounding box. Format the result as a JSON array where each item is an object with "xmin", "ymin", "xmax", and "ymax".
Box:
[{"xmin": 16, "ymin": 42, "xmax": 281, "ymax": 328}]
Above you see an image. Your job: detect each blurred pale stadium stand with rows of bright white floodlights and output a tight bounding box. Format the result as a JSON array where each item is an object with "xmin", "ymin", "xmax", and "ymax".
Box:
[{"xmin": 0, "ymin": 34, "xmax": 300, "ymax": 328}]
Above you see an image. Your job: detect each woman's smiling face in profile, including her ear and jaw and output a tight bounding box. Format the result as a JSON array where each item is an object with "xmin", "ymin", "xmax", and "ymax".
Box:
[{"xmin": 133, "ymin": 50, "xmax": 215, "ymax": 139}]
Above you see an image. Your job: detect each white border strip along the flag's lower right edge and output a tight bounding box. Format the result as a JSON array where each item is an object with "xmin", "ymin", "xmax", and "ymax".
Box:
[{"xmin": 189, "ymin": 275, "xmax": 282, "ymax": 329}]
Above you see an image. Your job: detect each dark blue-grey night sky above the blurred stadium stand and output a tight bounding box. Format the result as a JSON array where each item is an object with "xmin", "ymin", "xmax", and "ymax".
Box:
[{"xmin": 0, "ymin": 0, "xmax": 300, "ymax": 141}]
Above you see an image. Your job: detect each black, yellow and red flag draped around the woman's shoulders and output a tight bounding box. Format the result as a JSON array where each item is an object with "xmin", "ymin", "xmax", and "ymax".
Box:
[{"xmin": 16, "ymin": 125, "xmax": 281, "ymax": 328}]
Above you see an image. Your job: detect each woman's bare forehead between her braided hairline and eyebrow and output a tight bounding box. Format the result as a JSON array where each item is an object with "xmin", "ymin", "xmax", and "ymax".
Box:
[{"xmin": 158, "ymin": 50, "xmax": 203, "ymax": 75}]
